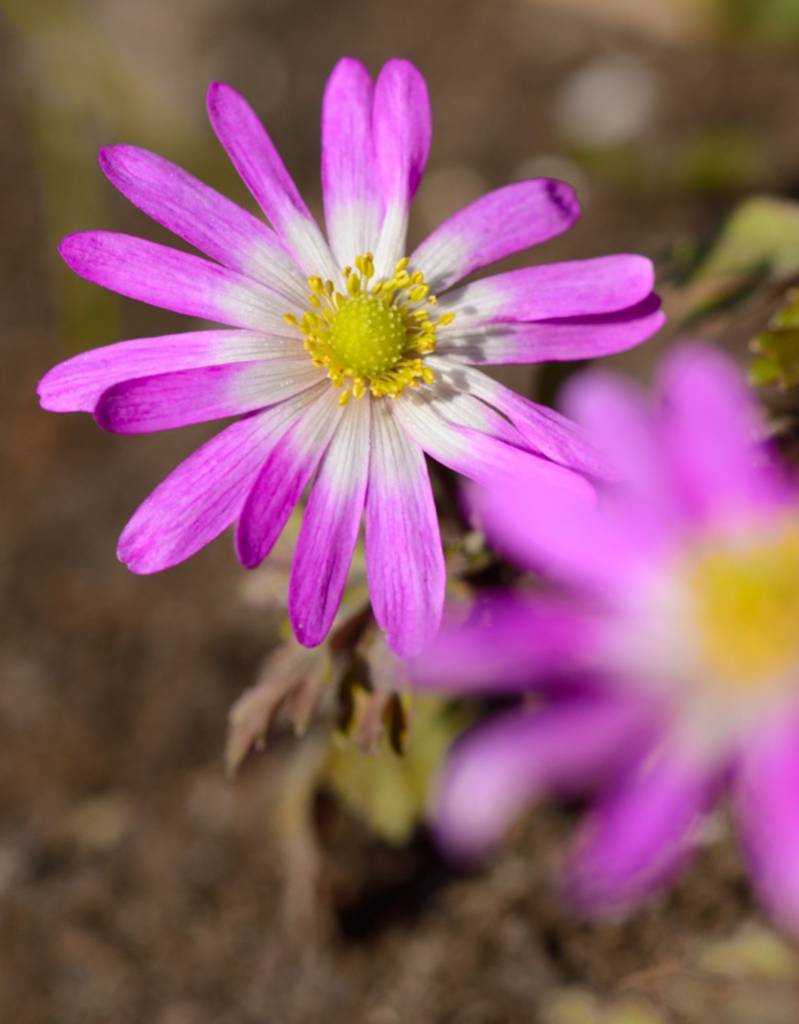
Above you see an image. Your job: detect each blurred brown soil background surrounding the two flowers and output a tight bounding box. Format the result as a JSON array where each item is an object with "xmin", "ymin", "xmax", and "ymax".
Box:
[{"xmin": 0, "ymin": 0, "xmax": 799, "ymax": 1024}]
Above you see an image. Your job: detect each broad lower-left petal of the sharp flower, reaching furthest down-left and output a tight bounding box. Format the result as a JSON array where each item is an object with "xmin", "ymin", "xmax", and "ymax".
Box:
[{"xmin": 117, "ymin": 395, "xmax": 321, "ymax": 573}]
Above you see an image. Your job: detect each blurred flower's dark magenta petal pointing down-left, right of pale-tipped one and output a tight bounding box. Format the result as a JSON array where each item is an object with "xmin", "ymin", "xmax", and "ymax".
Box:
[{"xmin": 566, "ymin": 749, "xmax": 722, "ymax": 912}]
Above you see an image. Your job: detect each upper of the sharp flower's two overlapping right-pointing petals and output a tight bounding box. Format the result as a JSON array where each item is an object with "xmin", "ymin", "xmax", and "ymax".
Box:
[{"xmin": 439, "ymin": 254, "xmax": 655, "ymax": 323}]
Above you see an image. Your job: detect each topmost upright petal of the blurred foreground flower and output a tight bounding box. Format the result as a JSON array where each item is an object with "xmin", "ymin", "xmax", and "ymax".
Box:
[{"xmin": 661, "ymin": 345, "xmax": 786, "ymax": 521}]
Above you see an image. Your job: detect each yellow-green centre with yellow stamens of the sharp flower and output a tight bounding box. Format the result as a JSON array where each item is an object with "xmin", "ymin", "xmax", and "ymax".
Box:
[{"xmin": 284, "ymin": 253, "xmax": 455, "ymax": 406}]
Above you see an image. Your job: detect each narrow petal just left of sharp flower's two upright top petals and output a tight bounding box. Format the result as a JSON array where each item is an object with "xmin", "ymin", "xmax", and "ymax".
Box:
[{"xmin": 208, "ymin": 82, "xmax": 339, "ymax": 281}]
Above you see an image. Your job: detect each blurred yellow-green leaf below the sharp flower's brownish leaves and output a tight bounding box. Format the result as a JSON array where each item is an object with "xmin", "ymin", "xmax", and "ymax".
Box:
[{"xmin": 324, "ymin": 695, "xmax": 467, "ymax": 844}]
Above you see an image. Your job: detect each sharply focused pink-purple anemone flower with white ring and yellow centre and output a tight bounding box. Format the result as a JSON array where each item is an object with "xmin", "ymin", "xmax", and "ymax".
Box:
[{"xmin": 39, "ymin": 59, "xmax": 662, "ymax": 653}]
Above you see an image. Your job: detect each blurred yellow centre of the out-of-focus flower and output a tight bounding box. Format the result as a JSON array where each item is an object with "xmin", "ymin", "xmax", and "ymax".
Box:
[{"xmin": 690, "ymin": 522, "xmax": 799, "ymax": 688}]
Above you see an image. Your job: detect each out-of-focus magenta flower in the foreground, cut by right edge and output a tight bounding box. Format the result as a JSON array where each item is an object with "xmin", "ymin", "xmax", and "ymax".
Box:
[{"xmin": 424, "ymin": 346, "xmax": 799, "ymax": 932}]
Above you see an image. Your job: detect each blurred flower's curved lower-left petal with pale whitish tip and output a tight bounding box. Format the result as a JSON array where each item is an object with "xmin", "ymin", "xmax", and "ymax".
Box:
[{"xmin": 433, "ymin": 697, "xmax": 645, "ymax": 859}]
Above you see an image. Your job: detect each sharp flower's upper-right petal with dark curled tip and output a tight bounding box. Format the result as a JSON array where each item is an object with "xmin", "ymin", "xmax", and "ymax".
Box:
[{"xmin": 411, "ymin": 178, "xmax": 580, "ymax": 293}]
